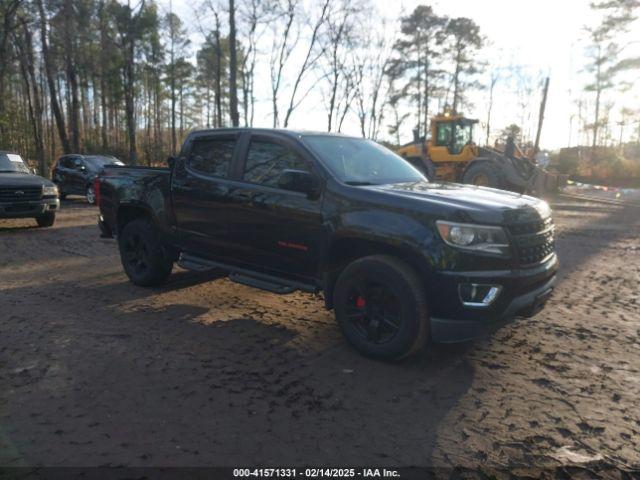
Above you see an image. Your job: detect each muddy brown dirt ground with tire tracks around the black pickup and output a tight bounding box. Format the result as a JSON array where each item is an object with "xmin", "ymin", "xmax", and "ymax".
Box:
[{"xmin": 0, "ymin": 199, "xmax": 640, "ymax": 470}]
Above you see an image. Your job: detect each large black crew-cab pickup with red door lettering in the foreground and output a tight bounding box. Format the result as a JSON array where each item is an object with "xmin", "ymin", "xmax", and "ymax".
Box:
[{"xmin": 94, "ymin": 129, "xmax": 558, "ymax": 359}]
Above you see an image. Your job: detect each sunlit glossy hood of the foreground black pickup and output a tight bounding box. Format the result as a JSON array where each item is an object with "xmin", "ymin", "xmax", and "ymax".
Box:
[{"xmin": 365, "ymin": 182, "xmax": 551, "ymax": 224}]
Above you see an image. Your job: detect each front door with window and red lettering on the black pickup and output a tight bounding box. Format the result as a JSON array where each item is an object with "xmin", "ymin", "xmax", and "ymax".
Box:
[{"xmin": 228, "ymin": 134, "xmax": 325, "ymax": 279}]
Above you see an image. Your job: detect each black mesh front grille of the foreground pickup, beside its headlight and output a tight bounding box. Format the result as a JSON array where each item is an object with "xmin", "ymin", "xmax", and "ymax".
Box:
[{"xmin": 509, "ymin": 217, "xmax": 555, "ymax": 266}]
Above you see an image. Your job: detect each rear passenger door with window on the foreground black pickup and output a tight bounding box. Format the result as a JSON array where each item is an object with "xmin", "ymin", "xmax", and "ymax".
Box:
[{"xmin": 171, "ymin": 133, "xmax": 238, "ymax": 259}]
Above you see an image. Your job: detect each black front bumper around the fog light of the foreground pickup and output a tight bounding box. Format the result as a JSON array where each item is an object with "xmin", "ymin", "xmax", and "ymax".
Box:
[{"xmin": 428, "ymin": 254, "xmax": 558, "ymax": 343}]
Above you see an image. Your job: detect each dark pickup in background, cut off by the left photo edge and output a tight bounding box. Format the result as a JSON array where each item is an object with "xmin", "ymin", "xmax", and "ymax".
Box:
[{"xmin": 0, "ymin": 151, "xmax": 60, "ymax": 227}]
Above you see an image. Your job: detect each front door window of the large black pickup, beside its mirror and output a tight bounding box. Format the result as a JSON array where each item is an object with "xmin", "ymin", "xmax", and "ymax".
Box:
[{"xmin": 243, "ymin": 140, "xmax": 310, "ymax": 187}]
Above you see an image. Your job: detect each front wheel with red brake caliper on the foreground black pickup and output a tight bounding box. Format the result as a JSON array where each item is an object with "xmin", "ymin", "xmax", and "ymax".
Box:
[{"xmin": 334, "ymin": 255, "xmax": 429, "ymax": 360}]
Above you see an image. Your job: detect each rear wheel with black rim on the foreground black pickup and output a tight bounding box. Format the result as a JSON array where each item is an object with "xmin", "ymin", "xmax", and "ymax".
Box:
[{"xmin": 119, "ymin": 218, "xmax": 173, "ymax": 287}]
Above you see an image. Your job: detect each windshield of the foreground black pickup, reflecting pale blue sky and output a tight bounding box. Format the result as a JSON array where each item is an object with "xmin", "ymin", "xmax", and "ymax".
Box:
[{"xmin": 303, "ymin": 135, "xmax": 426, "ymax": 185}]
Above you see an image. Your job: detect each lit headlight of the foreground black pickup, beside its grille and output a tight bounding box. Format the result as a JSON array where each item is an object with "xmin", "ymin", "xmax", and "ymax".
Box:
[{"xmin": 436, "ymin": 220, "xmax": 511, "ymax": 258}]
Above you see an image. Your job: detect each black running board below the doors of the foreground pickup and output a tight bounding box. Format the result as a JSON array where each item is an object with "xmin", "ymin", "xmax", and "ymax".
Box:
[{"xmin": 178, "ymin": 253, "xmax": 318, "ymax": 294}]
